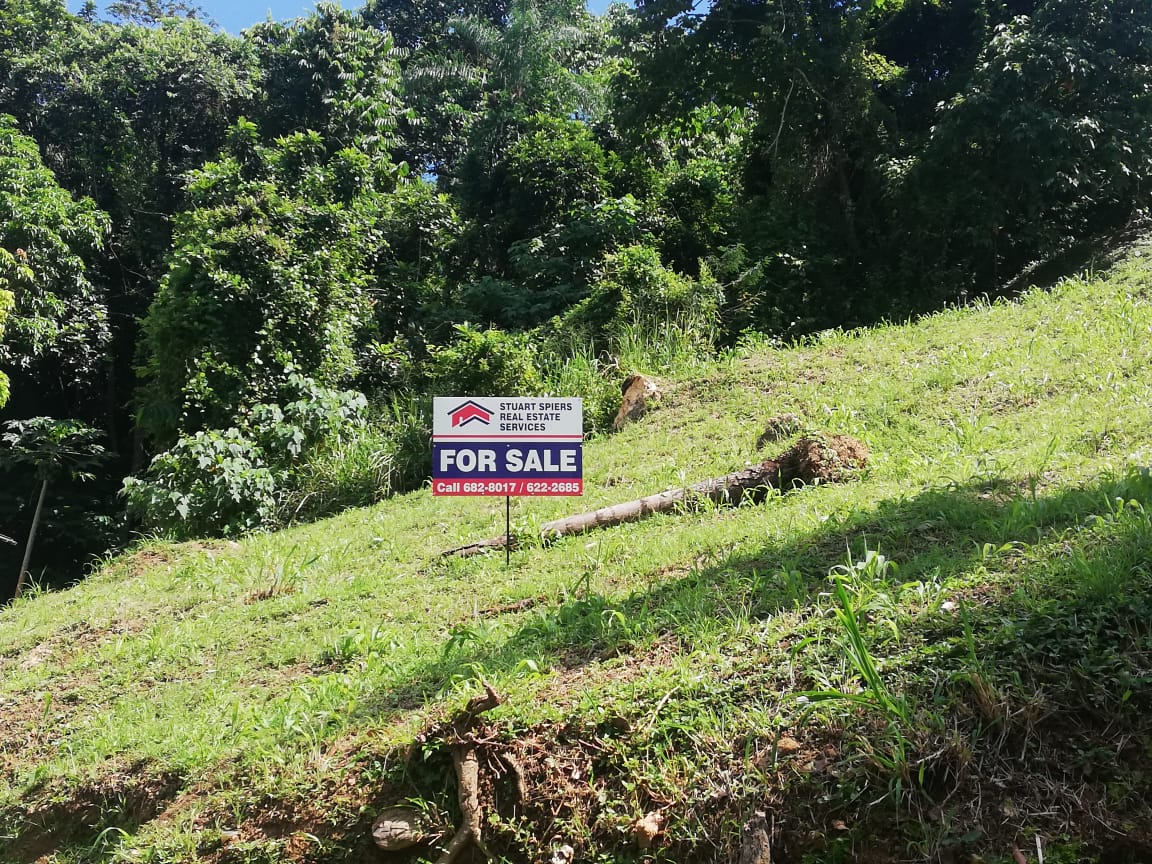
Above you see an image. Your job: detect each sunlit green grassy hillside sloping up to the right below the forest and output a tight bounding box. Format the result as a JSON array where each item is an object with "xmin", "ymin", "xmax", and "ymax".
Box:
[{"xmin": 0, "ymin": 248, "xmax": 1152, "ymax": 864}]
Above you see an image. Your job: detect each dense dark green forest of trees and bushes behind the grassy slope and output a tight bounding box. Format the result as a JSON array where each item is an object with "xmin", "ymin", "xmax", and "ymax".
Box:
[{"xmin": 0, "ymin": 0, "xmax": 1152, "ymax": 589}]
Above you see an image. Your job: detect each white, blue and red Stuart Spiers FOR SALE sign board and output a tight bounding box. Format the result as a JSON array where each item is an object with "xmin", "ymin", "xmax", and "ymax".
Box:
[{"xmin": 432, "ymin": 396, "xmax": 584, "ymax": 495}]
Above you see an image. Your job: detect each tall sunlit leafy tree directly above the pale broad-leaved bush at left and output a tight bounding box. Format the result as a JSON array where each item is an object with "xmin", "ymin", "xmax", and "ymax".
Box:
[{"xmin": 138, "ymin": 120, "xmax": 396, "ymax": 446}]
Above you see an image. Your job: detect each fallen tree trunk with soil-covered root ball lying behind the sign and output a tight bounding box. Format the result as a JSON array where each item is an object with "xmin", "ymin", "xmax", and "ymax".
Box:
[{"xmin": 441, "ymin": 433, "xmax": 869, "ymax": 556}]
